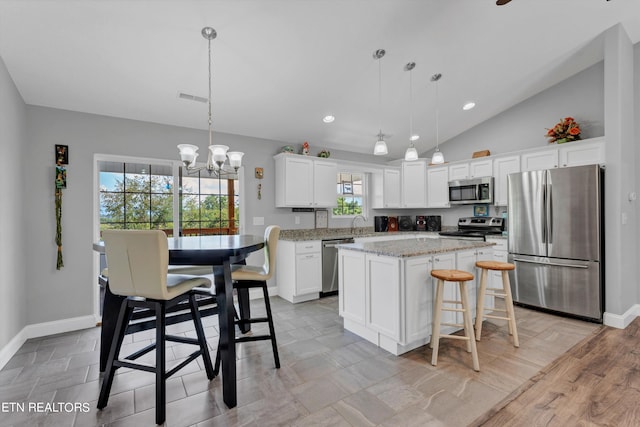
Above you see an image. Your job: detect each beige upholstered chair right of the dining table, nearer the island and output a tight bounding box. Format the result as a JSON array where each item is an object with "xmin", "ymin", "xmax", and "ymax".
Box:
[{"xmin": 214, "ymin": 225, "xmax": 280, "ymax": 375}]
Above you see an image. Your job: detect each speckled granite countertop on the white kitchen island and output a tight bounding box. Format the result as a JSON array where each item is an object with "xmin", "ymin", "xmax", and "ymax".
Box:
[{"xmin": 338, "ymin": 237, "xmax": 495, "ymax": 258}]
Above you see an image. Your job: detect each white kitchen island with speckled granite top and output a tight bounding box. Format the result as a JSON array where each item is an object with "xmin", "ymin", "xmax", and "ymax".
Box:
[{"xmin": 338, "ymin": 237, "xmax": 494, "ymax": 355}]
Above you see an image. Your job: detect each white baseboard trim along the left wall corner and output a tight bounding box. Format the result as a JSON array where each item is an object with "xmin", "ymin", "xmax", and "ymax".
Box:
[{"xmin": 0, "ymin": 315, "xmax": 96, "ymax": 369}]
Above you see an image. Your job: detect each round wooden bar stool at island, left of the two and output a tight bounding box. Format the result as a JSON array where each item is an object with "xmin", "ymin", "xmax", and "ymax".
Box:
[{"xmin": 430, "ymin": 270, "xmax": 480, "ymax": 371}]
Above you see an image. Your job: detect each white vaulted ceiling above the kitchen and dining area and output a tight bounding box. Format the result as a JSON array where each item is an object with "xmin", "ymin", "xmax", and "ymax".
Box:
[{"xmin": 0, "ymin": 0, "xmax": 640, "ymax": 159}]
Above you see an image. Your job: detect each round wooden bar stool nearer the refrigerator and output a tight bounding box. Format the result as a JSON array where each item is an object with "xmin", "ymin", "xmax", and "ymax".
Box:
[{"xmin": 476, "ymin": 261, "xmax": 520, "ymax": 347}]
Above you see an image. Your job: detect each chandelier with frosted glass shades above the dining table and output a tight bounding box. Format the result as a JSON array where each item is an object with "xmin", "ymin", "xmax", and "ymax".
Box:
[{"xmin": 178, "ymin": 27, "xmax": 244, "ymax": 176}]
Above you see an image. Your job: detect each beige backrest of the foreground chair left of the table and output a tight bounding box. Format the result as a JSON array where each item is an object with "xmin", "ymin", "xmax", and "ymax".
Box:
[{"xmin": 102, "ymin": 230, "xmax": 169, "ymax": 300}]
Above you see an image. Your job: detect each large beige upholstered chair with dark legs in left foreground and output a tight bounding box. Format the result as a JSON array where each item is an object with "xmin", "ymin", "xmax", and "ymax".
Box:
[{"xmin": 98, "ymin": 230, "xmax": 214, "ymax": 424}]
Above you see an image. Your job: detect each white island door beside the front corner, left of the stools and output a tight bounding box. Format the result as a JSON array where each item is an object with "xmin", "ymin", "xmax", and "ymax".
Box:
[{"xmin": 365, "ymin": 255, "xmax": 400, "ymax": 341}]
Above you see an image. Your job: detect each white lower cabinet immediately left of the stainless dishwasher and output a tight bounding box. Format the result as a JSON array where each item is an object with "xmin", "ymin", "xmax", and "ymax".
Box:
[{"xmin": 276, "ymin": 240, "xmax": 322, "ymax": 303}]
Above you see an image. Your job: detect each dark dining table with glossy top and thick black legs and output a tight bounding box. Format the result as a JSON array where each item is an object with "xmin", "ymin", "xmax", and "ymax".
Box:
[{"xmin": 93, "ymin": 234, "xmax": 265, "ymax": 408}]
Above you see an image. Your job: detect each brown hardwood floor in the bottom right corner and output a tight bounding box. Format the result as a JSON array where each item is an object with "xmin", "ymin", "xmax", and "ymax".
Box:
[{"xmin": 476, "ymin": 319, "xmax": 640, "ymax": 427}]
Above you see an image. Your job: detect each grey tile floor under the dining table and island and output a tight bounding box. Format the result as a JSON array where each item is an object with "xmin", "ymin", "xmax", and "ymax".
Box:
[{"xmin": 0, "ymin": 297, "xmax": 599, "ymax": 427}]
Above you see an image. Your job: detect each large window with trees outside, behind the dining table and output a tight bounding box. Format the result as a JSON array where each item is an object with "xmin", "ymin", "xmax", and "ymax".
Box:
[{"xmin": 98, "ymin": 161, "xmax": 240, "ymax": 236}]
